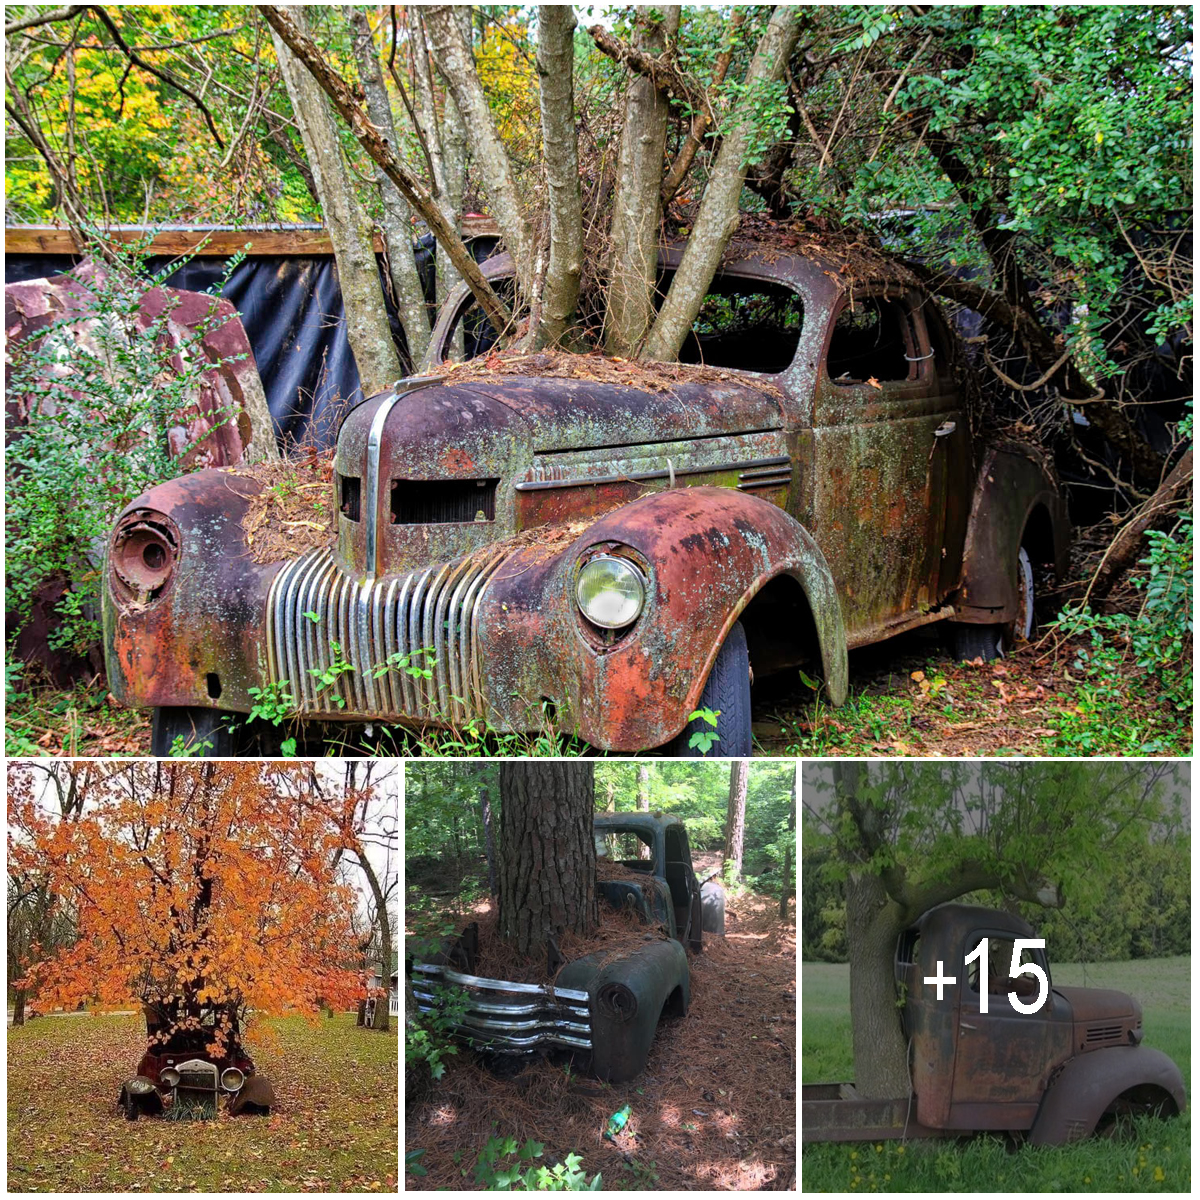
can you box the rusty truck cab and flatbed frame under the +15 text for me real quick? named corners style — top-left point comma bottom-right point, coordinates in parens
top-left (800, 904), bottom-right (1187, 1146)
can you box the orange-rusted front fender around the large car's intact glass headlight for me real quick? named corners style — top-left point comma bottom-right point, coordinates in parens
top-left (478, 487), bottom-right (847, 751)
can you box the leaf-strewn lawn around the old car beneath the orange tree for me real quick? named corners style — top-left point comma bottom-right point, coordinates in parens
top-left (8, 1014), bottom-right (398, 1192)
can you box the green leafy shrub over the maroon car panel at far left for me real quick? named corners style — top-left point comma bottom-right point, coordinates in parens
top-left (5, 238), bottom-right (248, 654)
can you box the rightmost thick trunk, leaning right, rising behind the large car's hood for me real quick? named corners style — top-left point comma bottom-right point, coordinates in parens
top-left (640, 5), bottom-right (800, 362)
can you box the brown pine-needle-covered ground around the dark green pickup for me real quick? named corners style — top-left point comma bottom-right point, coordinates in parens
top-left (404, 894), bottom-right (796, 1190)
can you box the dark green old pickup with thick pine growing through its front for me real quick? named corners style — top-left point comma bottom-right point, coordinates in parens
top-left (406, 812), bottom-right (725, 1082)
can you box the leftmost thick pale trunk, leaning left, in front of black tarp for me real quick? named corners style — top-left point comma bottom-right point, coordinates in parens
top-left (271, 7), bottom-right (403, 396)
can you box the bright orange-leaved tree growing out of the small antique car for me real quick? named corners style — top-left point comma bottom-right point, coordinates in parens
top-left (8, 762), bottom-right (364, 1054)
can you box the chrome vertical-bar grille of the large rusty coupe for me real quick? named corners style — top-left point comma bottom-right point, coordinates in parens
top-left (266, 548), bottom-right (505, 724)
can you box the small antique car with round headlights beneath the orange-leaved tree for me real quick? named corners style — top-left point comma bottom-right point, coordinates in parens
top-left (116, 1006), bottom-right (275, 1121)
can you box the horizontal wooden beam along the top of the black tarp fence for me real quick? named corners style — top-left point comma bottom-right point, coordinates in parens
top-left (4, 216), bottom-right (498, 258)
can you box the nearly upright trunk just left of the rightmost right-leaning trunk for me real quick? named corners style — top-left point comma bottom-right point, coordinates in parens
top-left (604, 5), bottom-right (683, 358)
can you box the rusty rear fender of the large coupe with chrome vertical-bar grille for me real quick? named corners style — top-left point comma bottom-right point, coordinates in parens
top-left (954, 442), bottom-right (1070, 624)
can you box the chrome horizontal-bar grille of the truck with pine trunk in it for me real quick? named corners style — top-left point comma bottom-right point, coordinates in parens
top-left (412, 962), bottom-right (592, 1054)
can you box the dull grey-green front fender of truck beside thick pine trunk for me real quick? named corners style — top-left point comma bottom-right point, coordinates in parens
top-left (554, 935), bottom-right (691, 1084)
